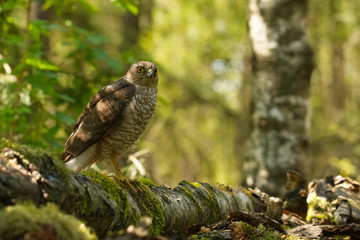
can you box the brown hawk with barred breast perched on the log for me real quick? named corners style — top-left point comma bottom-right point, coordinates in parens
top-left (60, 61), bottom-right (158, 176)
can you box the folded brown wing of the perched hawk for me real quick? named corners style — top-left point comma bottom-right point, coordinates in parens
top-left (60, 78), bottom-right (135, 162)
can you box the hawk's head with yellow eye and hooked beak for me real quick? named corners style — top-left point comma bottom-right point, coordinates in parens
top-left (126, 61), bottom-right (158, 87)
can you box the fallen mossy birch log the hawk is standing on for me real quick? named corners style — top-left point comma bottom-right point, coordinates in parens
top-left (0, 142), bottom-right (259, 235)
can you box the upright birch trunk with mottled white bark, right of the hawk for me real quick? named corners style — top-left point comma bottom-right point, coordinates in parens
top-left (243, 0), bottom-right (313, 195)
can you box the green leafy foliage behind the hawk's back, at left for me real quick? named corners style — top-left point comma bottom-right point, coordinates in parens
top-left (0, 0), bottom-right (135, 149)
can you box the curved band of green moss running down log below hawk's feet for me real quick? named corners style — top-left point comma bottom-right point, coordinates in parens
top-left (121, 179), bottom-right (165, 236)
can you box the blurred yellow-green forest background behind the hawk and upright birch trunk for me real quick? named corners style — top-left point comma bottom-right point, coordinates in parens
top-left (0, 0), bottom-right (360, 186)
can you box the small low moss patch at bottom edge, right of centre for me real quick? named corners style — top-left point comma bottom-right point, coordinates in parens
top-left (232, 222), bottom-right (282, 240)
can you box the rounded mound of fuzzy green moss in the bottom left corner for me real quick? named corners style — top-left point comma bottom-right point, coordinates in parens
top-left (0, 203), bottom-right (97, 240)
